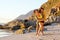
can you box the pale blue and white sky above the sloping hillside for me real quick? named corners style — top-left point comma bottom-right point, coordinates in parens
top-left (0, 0), bottom-right (47, 23)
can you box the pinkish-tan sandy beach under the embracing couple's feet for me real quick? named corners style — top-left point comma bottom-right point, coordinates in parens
top-left (0, 23), bottom-right (60, 40)
